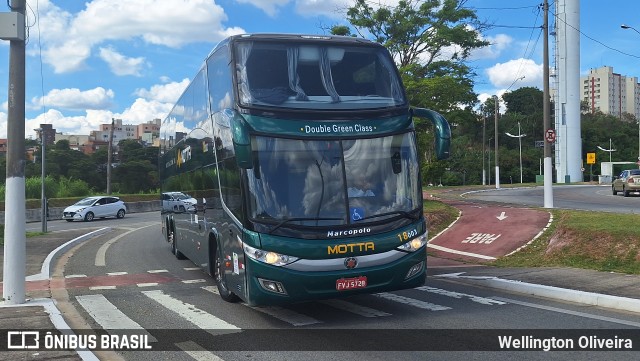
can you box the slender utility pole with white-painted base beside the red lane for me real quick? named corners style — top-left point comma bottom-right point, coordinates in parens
top-left (542, 0), bottom-right (553, 208)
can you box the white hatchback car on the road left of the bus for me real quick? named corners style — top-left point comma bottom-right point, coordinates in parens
top-left (62, 196), bottom-right (127, 222)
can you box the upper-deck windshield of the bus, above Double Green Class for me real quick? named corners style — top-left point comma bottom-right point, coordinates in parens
top-left (235, 41), bottom-right (406, 110)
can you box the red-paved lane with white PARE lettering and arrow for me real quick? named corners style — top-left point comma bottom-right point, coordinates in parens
top-left (428, 200), bottom-right (551, 262)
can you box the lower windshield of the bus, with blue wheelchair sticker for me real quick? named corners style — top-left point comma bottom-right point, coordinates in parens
top-left (247, 133), bottom-right (421, 227)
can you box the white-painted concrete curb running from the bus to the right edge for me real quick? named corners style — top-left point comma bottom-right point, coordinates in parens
top-left (434, 273), bottom-right (640, 313)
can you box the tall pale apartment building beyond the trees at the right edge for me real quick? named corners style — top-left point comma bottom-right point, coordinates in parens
top-left (580, 66), bottom-right (640, 119)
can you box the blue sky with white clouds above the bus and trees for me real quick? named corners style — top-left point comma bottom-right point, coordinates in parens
top-left (0, 0), bottom-right (640, 138)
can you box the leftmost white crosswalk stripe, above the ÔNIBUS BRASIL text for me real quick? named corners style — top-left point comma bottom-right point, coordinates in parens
top-left (76, 295), bottom-right (157, 342)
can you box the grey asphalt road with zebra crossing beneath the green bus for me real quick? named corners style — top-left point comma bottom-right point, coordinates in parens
top-left (48, 215), bottom-right (640, 361)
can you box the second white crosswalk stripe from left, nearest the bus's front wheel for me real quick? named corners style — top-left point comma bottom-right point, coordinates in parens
top-left (142, 290), bottom-right (240, 330)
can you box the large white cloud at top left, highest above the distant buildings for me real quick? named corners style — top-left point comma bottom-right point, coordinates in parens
top-left (39, 0), bottom-right (244, 73)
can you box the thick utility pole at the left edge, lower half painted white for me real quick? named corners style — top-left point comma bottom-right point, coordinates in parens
top-left (2, 0), bottom-right (27, 305)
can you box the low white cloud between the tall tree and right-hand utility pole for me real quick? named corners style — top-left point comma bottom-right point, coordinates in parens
top-left (486, 58), bottom-right (542, 88)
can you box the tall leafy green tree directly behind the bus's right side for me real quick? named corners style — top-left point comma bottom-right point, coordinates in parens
top-left (331, 0), bottom-right (489, 184)
